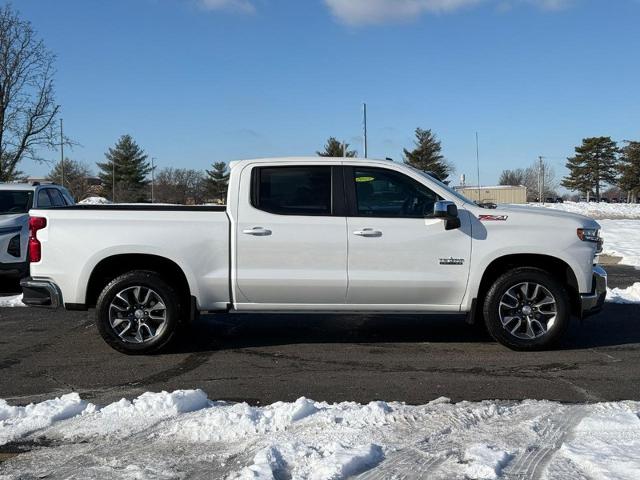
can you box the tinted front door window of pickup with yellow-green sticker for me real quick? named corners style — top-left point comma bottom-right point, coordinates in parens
top-left (353, 167), bottom-right (439, 218)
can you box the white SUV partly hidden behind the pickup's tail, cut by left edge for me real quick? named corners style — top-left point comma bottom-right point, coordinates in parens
top-left (0, 182), bottom-right (74, 279)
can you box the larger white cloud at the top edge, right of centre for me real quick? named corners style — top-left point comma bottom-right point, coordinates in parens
top-left (324, 0), bottom-right (574, 25)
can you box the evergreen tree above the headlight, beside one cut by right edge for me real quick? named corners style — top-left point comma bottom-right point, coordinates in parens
top-left (562, 137), bottom-right (619, 201)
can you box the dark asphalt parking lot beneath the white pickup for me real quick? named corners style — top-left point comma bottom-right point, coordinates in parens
top-left (0, 266), bottom-right (640, 404)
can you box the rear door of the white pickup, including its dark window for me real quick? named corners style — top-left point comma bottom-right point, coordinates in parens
top-left (235, 164), bottom-right (347, 310)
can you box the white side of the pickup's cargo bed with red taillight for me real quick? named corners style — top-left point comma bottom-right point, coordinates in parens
top-left (30, 204), bottom-right (230, 310)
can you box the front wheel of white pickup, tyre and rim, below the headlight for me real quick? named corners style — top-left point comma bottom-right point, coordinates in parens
top-left (483, 268), bottom-right (570, 350)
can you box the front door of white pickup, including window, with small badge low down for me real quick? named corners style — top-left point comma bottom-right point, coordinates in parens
top-left (345, 166), bottom-right (471, 310)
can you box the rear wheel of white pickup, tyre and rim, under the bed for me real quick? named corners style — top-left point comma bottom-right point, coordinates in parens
top-left (96, 270), bottom-right (180, 355)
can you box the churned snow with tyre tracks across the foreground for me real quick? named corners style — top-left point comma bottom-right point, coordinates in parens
top-left (0, 390), bottom-right (640, 480)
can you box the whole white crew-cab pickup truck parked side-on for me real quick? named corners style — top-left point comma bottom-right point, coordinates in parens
top-left (22, 158), bottom-right (607, 354)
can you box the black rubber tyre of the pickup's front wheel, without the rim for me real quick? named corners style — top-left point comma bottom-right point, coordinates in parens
top-left (482, 267), bottom-right (571, 351)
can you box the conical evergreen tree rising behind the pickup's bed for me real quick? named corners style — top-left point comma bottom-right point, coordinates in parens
top-left (98, 135), bottom-right (151, 202)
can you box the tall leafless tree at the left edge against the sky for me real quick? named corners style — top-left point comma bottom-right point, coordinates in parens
top-left (0, 4), bottom-right (60, 181)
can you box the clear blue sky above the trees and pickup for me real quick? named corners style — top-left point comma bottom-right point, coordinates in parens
top-left (13, 0), bottom-right (640, 184)
